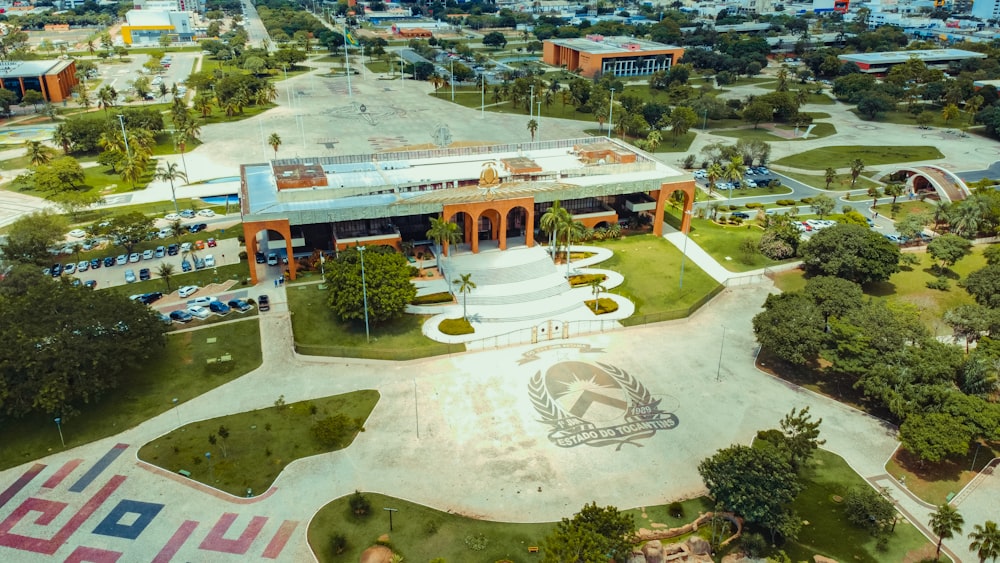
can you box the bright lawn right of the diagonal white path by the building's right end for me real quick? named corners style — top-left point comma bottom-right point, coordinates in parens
top-left (666, 207), bottom-right (796, 276)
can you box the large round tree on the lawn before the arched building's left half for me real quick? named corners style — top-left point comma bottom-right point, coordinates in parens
top-left (326, 246), bottom-right (417, 324)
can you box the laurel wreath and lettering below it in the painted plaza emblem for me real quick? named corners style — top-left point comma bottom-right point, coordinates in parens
top-left (528, 362), bottom-right (677, 450)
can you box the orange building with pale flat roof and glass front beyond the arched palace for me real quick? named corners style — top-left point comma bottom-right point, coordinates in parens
top-left (542, 35), bottom-right (684, 78)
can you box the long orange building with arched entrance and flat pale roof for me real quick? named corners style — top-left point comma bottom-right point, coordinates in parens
top-left (240, 137), bottom-right (695, 283)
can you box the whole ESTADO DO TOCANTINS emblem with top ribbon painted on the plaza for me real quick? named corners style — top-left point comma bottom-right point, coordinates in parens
top-left (521, 345), bottom-right (679, 450)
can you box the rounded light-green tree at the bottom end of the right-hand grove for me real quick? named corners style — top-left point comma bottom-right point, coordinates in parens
top-left (899, 412), bottom-right (972, 468)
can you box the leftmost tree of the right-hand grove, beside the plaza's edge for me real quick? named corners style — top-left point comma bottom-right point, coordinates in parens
top-left (753, 293), bottom-right (826, 365)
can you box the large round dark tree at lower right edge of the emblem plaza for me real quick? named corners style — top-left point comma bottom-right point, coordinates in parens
top-left (698, 445), bottom-right (802, 539)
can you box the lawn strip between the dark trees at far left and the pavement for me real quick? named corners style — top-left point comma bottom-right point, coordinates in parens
top-left (0, 321), bottom-right (261, 469)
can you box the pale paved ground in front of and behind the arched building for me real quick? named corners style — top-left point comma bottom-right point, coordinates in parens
top-left (0, 55), bottom-right (1000, 562)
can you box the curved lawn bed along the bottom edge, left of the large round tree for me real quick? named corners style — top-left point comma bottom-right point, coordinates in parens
top-left (308, 490), bottom-right (712, 563)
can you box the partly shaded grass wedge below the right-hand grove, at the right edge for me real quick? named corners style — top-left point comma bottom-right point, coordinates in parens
top-left (885, 442), bottom-right (1000, 505)
